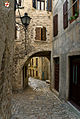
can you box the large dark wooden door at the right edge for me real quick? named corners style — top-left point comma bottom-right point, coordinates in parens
top-left (70, 56), bottom-right (80, 106)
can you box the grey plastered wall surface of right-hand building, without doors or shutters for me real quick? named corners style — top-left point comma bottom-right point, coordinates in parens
top-left (52, 0), bottom-right (80, 99)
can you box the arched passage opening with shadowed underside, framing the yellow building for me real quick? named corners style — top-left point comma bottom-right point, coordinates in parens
top-left (22, 51), bottom-right (51, 89)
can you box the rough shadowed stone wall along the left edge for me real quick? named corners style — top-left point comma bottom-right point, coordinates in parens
top-left (0, 0), bottom-right (14, 119)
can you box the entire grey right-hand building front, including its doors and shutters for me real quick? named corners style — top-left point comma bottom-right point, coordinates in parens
top-left (52, 0), bottom-right (80, 109)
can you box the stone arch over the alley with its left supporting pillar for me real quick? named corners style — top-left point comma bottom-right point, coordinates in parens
top-left (12, 49), bottom-right (51, 90)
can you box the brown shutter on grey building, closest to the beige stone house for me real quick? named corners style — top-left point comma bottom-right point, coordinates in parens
top-left (53, 14), bottom-right (58, 37)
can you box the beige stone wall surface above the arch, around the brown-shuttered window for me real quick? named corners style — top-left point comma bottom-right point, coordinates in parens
top-left (13, 0), bottom-right (52, 89)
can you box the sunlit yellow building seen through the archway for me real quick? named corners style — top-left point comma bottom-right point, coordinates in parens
top-left (28, 57), bottom-right (50, 81)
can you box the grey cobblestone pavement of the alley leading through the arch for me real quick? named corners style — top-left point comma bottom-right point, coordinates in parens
top-left (11, 78), bottom-right (80, 119)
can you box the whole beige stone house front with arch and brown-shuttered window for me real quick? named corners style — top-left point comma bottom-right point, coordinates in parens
top-left (13, 0), bottom-right (52, 90)
